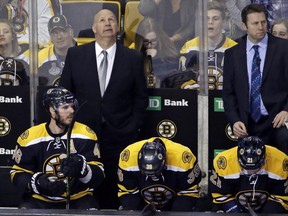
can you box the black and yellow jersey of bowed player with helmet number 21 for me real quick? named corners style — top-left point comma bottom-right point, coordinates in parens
top-left (210, 145), bottom-right (288, 212)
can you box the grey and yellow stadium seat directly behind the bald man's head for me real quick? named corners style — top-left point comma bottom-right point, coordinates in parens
top-left (61, 0), bottom-right (121, 45)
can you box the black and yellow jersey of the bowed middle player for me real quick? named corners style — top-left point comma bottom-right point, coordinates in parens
top-left (118, 137), bottom-right (201, 210)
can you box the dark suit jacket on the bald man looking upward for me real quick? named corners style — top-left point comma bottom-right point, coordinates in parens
top-left (60, 42), bottom-right (148, 148)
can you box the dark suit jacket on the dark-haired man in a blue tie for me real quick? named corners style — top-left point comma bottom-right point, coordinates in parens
top-left (223, 34), bottom-right (288, 127)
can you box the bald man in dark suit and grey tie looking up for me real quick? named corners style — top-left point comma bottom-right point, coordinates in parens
top-left (59, 9), bottom-right (148, 209)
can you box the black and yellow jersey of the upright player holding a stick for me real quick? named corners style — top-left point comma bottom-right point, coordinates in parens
top-left (10, 122), bottom-right (104, 202)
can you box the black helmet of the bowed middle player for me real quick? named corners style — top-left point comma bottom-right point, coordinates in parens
top-left (138, 139), bottom-right (166, 176)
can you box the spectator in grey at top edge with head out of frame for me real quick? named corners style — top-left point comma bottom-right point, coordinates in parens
top-left (138, 0), bottom-right (197, 50)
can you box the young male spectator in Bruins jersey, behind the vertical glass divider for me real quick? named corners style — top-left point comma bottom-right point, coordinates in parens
top-left (180, 1), bottom-right (236, 90)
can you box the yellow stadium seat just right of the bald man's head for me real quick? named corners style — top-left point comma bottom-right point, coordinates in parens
top-left (124, 1), bottom-right (143, 47)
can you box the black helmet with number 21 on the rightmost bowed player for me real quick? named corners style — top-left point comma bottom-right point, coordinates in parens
top-left (237, 136), bottom-right (266, 170)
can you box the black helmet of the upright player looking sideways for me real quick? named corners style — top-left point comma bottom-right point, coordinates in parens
top-left (43, 87), bottom-right (78, 112)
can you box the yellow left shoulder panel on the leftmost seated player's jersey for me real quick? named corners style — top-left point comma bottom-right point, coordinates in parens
top-left (17, 123), bottom-right (49, 147)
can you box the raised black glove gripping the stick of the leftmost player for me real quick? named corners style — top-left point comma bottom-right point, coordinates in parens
top-left (60, 154), bottom-right (88, 178)
